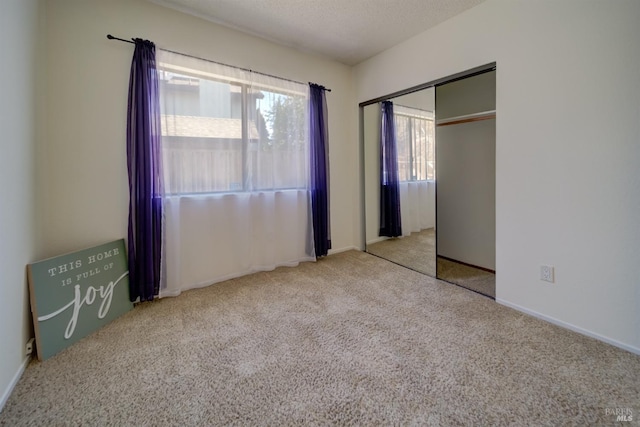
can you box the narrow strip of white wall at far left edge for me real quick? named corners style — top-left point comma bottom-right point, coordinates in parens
top-left (0, 0), bottom-right (39, 409)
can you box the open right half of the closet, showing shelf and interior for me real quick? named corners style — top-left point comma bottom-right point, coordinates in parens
top-left (436, 71), bottom-right (496, 298)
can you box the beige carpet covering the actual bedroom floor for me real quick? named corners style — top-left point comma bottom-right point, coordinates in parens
top-left (0, 251), bottom-right (640, 426)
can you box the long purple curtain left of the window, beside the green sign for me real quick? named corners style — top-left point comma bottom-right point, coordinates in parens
top-left (127, 39), bottom-right (162, 301)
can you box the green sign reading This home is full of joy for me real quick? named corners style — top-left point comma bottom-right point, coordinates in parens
top-left (27, 239), bottom-right (133, 360)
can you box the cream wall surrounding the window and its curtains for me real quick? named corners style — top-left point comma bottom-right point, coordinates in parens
top-left (40, 0), bottom-right (359, 255)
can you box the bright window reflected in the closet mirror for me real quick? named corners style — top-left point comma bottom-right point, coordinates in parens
top-left (394, 105), bottom-right (435, 181)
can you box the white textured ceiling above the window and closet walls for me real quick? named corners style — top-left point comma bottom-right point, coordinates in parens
top-left (150, 0), bottom-right (485, 65)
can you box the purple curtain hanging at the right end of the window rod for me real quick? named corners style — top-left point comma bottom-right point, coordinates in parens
top-left (309, 83), bottom-right (331, 257)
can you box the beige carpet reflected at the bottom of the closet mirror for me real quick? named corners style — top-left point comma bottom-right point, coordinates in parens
top-left (367, 228), bottom-right (436, 277)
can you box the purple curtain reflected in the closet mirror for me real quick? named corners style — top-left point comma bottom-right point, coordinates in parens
top-left (379, 101), bottom-right (402, 237)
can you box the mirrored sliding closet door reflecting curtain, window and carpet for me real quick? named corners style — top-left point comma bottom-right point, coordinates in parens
top-left (363, 87), bottom-right (436, 277)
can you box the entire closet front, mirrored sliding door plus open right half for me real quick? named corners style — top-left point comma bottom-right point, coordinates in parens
top-left (360, 64), bottom-right (495, 298)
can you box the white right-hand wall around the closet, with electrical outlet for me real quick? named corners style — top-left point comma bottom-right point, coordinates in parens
top-left (354, 0), bottom-right (640, 353)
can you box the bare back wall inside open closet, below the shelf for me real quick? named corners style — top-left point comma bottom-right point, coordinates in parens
top-left (436, 119), bottom-right (496, 270)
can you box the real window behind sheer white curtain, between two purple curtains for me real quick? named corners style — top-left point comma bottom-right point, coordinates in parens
top-left (158, 51), bottom-right (308, 194)
